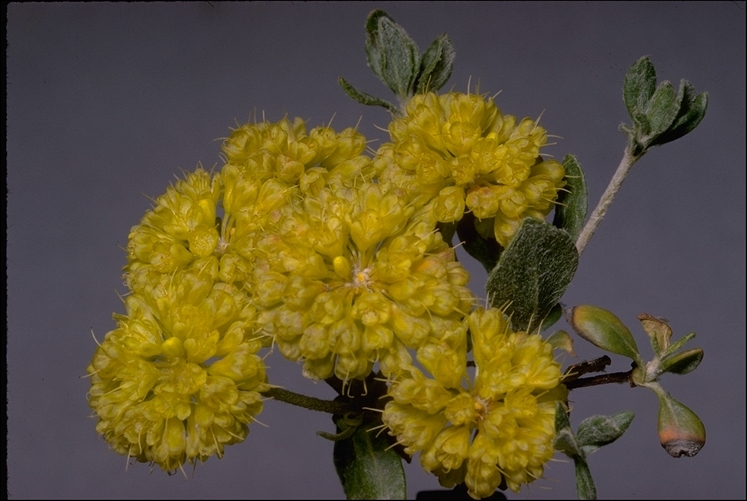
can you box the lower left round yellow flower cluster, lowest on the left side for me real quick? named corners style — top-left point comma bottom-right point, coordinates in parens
top-left (87, 270), bottom-right (269, 471)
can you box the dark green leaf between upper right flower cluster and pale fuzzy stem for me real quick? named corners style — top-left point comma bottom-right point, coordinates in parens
top-left (552, 154), bottom-right (589, 242)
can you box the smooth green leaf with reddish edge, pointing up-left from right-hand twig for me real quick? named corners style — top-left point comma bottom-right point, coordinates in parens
top-left (568, 305), bottom-right (644, 367)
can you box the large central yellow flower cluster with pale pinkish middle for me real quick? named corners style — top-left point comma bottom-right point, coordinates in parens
top-left (254, 180), bottom-right (472, 380)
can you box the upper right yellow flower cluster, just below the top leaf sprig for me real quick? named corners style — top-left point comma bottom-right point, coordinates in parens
top-left (378, 92), bottom-right (565, 247)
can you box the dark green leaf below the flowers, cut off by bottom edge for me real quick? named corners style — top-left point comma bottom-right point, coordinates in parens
top-left (333, 416), bottom-right (407, 499)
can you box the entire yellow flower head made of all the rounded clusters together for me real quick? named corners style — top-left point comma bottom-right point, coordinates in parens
top-left (88, 93), bottom-right (564, 484)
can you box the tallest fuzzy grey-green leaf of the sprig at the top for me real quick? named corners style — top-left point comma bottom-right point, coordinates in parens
top-left (366, 10), bottom-right (420, 101)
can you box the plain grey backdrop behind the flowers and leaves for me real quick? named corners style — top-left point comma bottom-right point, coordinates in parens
top-left (7, 2), bottom-right (745, 499)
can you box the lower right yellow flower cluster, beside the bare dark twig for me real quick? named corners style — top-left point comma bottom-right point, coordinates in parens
top-left (382, 309), bottom-right (567, 499)
